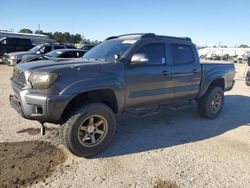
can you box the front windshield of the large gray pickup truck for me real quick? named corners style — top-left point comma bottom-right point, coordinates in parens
top-left (83, 39), bottom-right (136, 62)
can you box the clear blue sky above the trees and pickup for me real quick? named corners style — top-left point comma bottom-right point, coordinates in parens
top-left (0, 0), bottom-right (250, 46)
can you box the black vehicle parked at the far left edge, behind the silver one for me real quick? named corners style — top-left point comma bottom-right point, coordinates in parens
top-left (0, 37), bottom-right (34, 62)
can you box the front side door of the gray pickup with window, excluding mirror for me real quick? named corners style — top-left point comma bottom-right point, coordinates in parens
top-left (126, 42), bottom-right (171, 108)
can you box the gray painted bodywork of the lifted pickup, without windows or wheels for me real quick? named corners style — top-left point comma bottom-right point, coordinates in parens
top-left (9, 34), bottom-right (235, 123)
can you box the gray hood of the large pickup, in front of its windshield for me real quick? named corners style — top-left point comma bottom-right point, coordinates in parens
top-left (16, 58), bottom-right (109, 72)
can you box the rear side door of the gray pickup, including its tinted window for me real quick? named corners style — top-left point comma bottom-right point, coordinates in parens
top-left (169, 43), bottom-right (201, 101)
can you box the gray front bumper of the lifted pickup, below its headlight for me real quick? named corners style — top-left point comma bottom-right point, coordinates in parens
top-left (9, 83), bottom-right (70, 124)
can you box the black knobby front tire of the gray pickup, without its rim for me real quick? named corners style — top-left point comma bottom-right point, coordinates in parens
top-left (60, 103), bottom-right (116, 157)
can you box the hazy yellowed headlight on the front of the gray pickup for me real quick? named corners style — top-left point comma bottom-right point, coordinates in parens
top-left (28, 72), bottom-right (58, 90)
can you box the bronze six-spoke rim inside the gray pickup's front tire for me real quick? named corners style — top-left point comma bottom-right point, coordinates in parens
top-left (78, 115), bottom-right (108, 147)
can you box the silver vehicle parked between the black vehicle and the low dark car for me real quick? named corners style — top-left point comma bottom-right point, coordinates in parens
top-left (3, 43), bottom-right (75, 66)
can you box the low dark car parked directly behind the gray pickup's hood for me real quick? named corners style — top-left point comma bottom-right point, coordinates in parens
top-left (20, 49), bottom-right (85, 63)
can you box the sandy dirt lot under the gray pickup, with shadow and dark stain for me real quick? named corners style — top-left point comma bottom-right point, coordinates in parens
top-left (0, 65), bottom-right (250, 187)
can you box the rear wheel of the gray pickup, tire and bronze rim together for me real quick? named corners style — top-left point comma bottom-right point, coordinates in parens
top-left (197, 87), bottom-right (224, 119)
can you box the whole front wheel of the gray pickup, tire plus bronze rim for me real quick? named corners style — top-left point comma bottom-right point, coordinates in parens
top-left (61, 103), bottom-right (116, 157)
